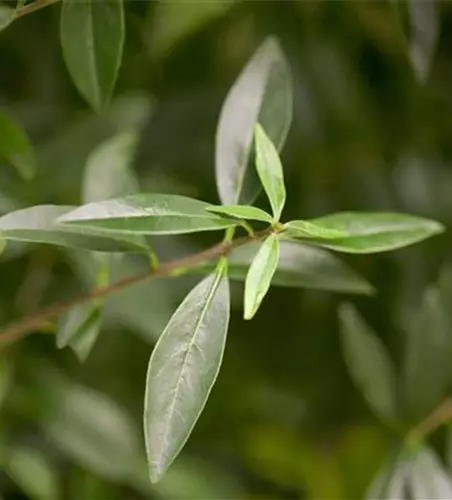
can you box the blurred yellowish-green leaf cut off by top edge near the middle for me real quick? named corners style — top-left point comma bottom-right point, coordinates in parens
top-left (147, 0), bottom-right (235, 56)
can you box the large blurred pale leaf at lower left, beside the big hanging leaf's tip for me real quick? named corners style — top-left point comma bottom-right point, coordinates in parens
top-left (39, 372), bottom-right (142, 482)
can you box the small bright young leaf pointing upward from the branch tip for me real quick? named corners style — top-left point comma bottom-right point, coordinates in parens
top-left (255, 124), bottom-right (286, 220)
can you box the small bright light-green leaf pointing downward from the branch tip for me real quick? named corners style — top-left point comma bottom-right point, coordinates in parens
top-left (244, 234), bottom-right (279, 319)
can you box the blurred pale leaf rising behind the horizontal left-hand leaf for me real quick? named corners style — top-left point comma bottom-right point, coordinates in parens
top-left (82, 132), bottom-right (138, 203)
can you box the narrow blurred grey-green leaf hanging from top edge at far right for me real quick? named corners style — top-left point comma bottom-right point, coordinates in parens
top-left (408, 0), bottom-right (439, 83)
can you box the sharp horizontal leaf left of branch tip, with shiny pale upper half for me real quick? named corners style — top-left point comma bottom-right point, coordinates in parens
top-left (60, 194), bottom-right (237, 234)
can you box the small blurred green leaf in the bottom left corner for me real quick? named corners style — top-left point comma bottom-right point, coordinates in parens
top-left (6, 446), bottom-right (59, 500)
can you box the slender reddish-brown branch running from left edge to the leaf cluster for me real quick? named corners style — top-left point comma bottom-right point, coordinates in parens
top-left (0, 229), bottom-right (271, 350)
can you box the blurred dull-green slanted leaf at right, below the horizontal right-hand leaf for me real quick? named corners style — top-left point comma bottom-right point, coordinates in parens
top-left (339, 304), bottom-right (397, 422)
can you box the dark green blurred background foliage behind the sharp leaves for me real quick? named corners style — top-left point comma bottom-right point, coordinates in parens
top-left (0, 0), bottom-right (452, 500)
